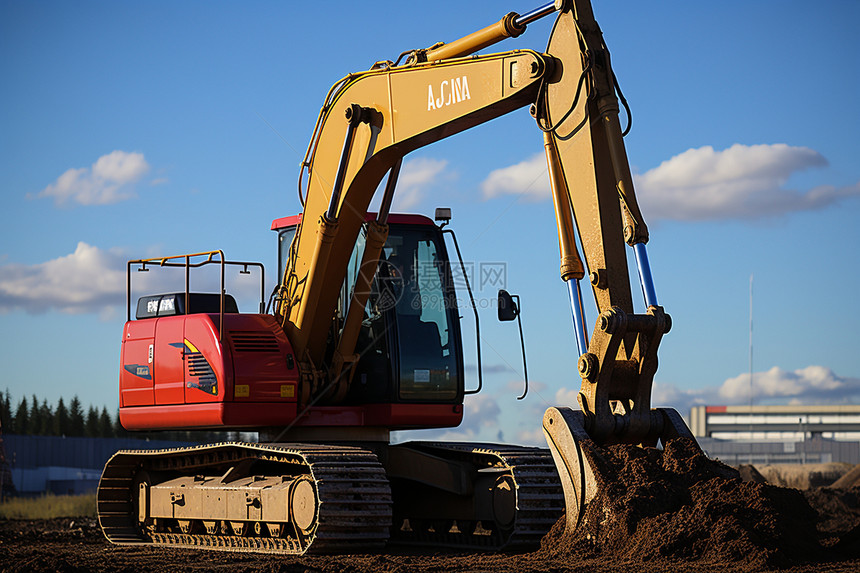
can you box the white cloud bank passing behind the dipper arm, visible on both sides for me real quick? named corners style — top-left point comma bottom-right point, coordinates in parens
top-left (481, 143), bottom-right (860, 220)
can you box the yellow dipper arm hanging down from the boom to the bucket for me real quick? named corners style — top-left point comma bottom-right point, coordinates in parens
top-left (537, 0), bottom-right (671, 443)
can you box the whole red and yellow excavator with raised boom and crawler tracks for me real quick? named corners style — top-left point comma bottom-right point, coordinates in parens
top-left (97, 0), bottom-right (692, 554)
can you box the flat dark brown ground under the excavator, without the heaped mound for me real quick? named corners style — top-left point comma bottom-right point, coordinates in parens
top-left (0, 519), bottom-right (860, 573)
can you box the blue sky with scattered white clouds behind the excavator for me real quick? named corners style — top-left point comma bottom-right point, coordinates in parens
top-left (0, 0), bottom-right (860, 443)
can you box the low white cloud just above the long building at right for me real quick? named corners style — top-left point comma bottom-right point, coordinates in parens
top-left (651, 365), bottom-right (860, 416)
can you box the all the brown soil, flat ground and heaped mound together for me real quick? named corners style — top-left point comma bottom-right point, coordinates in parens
top-left (0, 440), bottom-right (860, 573)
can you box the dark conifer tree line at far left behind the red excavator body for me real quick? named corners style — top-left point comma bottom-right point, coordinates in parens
top-left (0, 390), bottom-right (231, 442)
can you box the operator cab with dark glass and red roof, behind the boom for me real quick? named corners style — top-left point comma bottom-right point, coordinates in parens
top-left (272, 213), bottom-right (464, 404)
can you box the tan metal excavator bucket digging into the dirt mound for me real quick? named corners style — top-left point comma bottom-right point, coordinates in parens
top-left (543, 407), bottom-right (697, 533)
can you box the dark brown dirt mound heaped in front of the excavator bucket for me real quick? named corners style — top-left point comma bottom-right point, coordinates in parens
top-left (542, 439), bottom-right (823, 569)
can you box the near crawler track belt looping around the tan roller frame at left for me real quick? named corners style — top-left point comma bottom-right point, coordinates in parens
top-left (97, 444), bottom-right (392, 554)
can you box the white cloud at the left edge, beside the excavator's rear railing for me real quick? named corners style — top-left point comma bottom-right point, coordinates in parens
top-left (0, 242), bottom-right (125, 314)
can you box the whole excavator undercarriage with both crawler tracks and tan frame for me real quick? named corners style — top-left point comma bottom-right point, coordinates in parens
top-left (98, 442), bottom-right (564, 555)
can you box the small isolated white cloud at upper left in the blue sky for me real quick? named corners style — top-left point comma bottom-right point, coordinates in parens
top-left (31, 150), bottom-right (149, 205)
